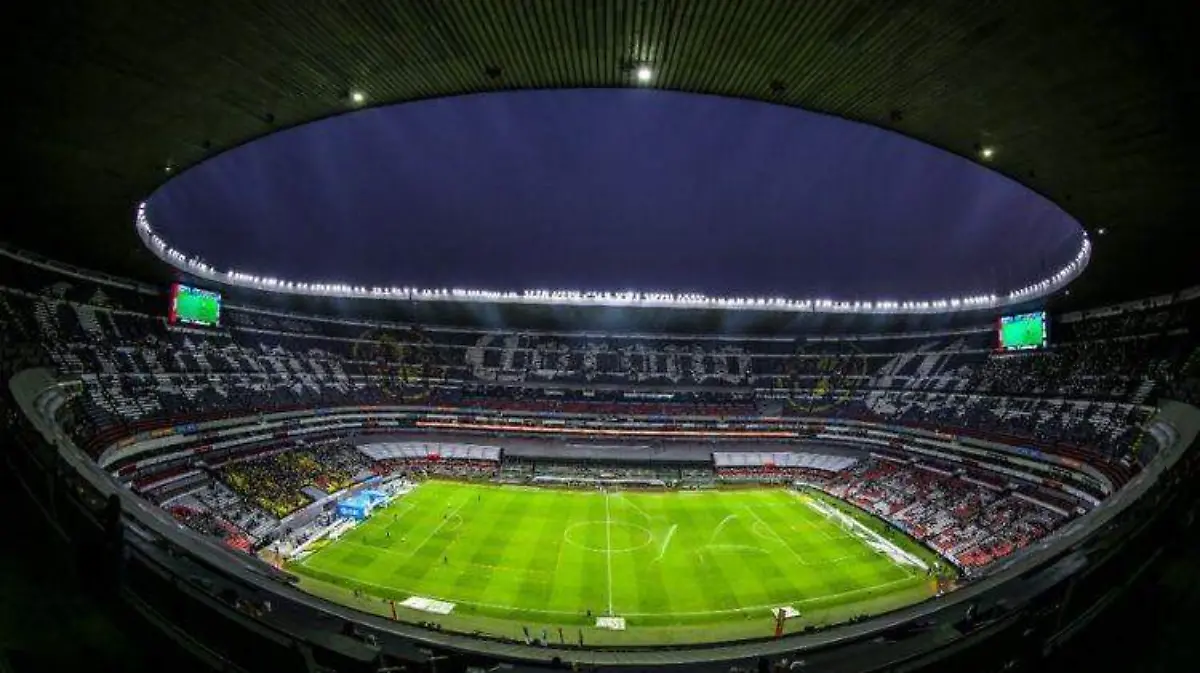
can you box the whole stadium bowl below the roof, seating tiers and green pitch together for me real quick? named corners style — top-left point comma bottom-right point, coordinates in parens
top-left (0, 239), bottom-right (1200, 662)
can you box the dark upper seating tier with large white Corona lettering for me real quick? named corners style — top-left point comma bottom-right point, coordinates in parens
top-left (0, 248), bottom-right (1200, 477)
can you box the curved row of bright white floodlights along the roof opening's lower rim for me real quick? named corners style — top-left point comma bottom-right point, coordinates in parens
top-left (136, 203), bottom-right (1092, 314)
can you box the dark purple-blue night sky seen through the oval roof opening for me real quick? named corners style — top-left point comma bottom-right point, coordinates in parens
top-left (149, 89), bottom-right (1082, 300)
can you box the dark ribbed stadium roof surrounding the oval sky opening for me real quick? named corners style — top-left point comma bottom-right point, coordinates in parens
top-left (4, 0), bottom-right (1200, 314)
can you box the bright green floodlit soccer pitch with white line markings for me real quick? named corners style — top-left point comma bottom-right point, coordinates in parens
top-left (289, 481), bottom-right (936, 643)
